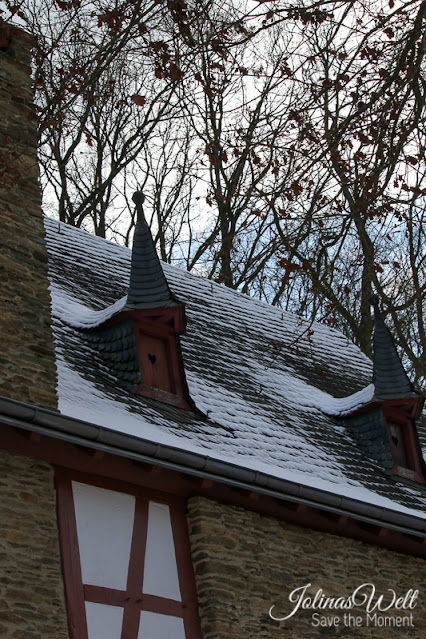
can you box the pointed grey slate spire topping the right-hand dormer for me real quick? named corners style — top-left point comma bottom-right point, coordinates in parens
top-left (370, 295), bottom-right (420, 400)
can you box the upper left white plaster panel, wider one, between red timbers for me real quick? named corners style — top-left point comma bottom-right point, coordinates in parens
top-left (72, 482), bottom-right (135, 590)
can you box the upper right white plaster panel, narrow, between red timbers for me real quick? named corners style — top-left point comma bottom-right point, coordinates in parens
top-left (143, 502), bottom-right (181, 601)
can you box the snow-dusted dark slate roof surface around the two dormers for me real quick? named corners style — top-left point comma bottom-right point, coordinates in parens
top-left (45, 219), bottom-right (426, 517)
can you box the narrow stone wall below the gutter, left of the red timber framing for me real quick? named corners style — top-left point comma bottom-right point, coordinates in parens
top-left (0, 451), bottom-right (68, 639)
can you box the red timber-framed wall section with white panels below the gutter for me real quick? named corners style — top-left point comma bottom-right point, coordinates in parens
top-left (57, 476), bottom-right (201, 639)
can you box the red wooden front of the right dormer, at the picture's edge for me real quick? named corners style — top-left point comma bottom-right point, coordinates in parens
top-left (382, 397), bottom-right (426, 484)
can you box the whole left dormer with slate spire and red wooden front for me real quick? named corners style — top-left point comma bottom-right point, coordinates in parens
top-left (91, 193), bottom-right (193, 409)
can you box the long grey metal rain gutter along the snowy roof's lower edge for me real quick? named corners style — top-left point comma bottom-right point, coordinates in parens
top-left (0, 397), bottom-right (426, 538)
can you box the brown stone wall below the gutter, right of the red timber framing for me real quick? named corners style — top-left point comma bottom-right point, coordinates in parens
top-left (188, 497), bottom-right (426, 639)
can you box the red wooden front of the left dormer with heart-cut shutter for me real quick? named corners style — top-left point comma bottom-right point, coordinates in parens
top-left (104, 306), bottom-right (191, 410)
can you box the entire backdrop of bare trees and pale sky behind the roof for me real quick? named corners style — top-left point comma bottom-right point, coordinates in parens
top-left (5, 0), bottom-right (426, 383)
